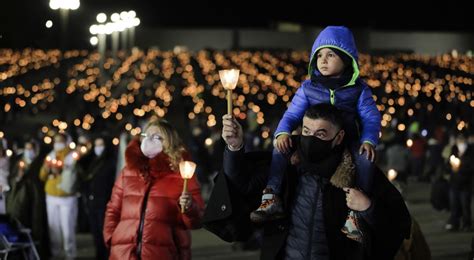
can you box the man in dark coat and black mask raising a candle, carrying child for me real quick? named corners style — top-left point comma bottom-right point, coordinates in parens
top-left (203, 105), bottom-right (411, 259)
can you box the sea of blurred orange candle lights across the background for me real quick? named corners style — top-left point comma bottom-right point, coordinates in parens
top-left (0, 49), bottom-right (474, 146)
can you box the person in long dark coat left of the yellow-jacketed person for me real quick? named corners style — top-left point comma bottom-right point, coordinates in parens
top-left (6, 142), bottom-right (50, 259)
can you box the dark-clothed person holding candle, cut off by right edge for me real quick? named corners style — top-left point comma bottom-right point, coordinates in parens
top-left (445, 134), bottom-right (474, 231)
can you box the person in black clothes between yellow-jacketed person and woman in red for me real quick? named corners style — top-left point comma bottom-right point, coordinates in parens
top-left (80, 137), bottom-right (116, 259)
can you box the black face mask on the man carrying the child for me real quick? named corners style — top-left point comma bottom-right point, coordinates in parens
top-left (299, 132), bottom-right (339, 163)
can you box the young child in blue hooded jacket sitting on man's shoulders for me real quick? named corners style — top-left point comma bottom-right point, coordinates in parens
top-left (250, 26), bottom-right (381, 240)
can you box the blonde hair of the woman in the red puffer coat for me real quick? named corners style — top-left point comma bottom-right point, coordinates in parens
top-left (145, 119), bottom-right (186, 171)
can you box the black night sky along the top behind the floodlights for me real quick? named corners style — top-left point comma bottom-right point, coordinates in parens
top-left (0, 0), bottom-right (474, 48)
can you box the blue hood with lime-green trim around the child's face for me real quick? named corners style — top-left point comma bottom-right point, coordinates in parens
top-left (308, 26), bottom-right (359, 86)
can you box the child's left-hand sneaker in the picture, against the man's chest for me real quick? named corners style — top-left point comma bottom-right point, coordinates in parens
top-left (250, 188), bottom-right (283, 223)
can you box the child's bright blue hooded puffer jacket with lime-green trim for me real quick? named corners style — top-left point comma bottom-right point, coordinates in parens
top-left (275, 26), bottom-right (381, 146)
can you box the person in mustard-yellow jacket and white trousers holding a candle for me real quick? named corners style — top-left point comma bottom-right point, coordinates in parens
top-left (39, 134), bottom-right (78, 259)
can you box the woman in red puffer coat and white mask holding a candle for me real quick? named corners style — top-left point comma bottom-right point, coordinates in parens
top-left (104, 120), bottom-right (204, 260)
